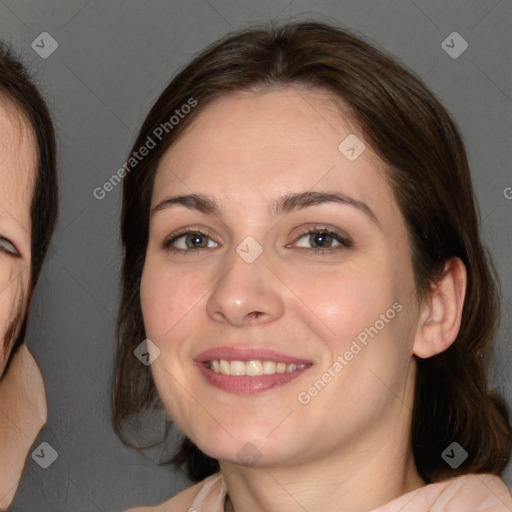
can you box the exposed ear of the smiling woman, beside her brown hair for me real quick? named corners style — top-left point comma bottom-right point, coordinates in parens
top-left (413, 257), bottom-right (467, 358)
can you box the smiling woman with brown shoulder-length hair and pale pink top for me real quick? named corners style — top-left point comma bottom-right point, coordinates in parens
top-left (113, 23), bottom-right (512, 512)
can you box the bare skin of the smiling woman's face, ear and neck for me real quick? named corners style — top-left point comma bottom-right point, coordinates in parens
top-left (140, 88), bottom-right (466, 512)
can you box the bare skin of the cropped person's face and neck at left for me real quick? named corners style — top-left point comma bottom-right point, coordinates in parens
top-left (0, 101), bottom-right (47, 510)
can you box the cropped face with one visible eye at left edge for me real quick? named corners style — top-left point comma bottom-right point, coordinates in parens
top-left (0, 100), bottom-right (36, 376)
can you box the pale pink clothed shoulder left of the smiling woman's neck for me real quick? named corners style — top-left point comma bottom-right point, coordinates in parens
top-left (126, 473), bottom-right (226, 512)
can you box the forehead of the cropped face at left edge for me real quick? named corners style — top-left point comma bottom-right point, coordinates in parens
top-left (0, 97), bottom-right (37, 227)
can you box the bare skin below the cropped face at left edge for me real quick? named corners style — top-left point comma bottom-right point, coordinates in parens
top-left (0, 344), bottom-right (47, 510)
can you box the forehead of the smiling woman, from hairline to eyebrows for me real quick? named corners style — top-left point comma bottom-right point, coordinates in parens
top-left (152, 87), bottom-right (396, 222)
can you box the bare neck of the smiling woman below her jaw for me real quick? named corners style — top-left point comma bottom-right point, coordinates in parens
top-left (220, 362), bottom-right (425, 512)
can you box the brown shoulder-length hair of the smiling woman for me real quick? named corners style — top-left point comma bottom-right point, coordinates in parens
top-left (112, 22), bottom-right (511, 482)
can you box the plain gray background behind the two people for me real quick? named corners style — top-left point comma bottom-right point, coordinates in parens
top-left (0, 0), bottom-right (512, 512)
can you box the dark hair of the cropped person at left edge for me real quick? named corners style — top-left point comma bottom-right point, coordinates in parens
top-left (0, 41), bottom-right (58, 364)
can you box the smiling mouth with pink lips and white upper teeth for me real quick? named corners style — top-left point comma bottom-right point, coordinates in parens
top-left (195, 349), bottom-right (312, 395)
